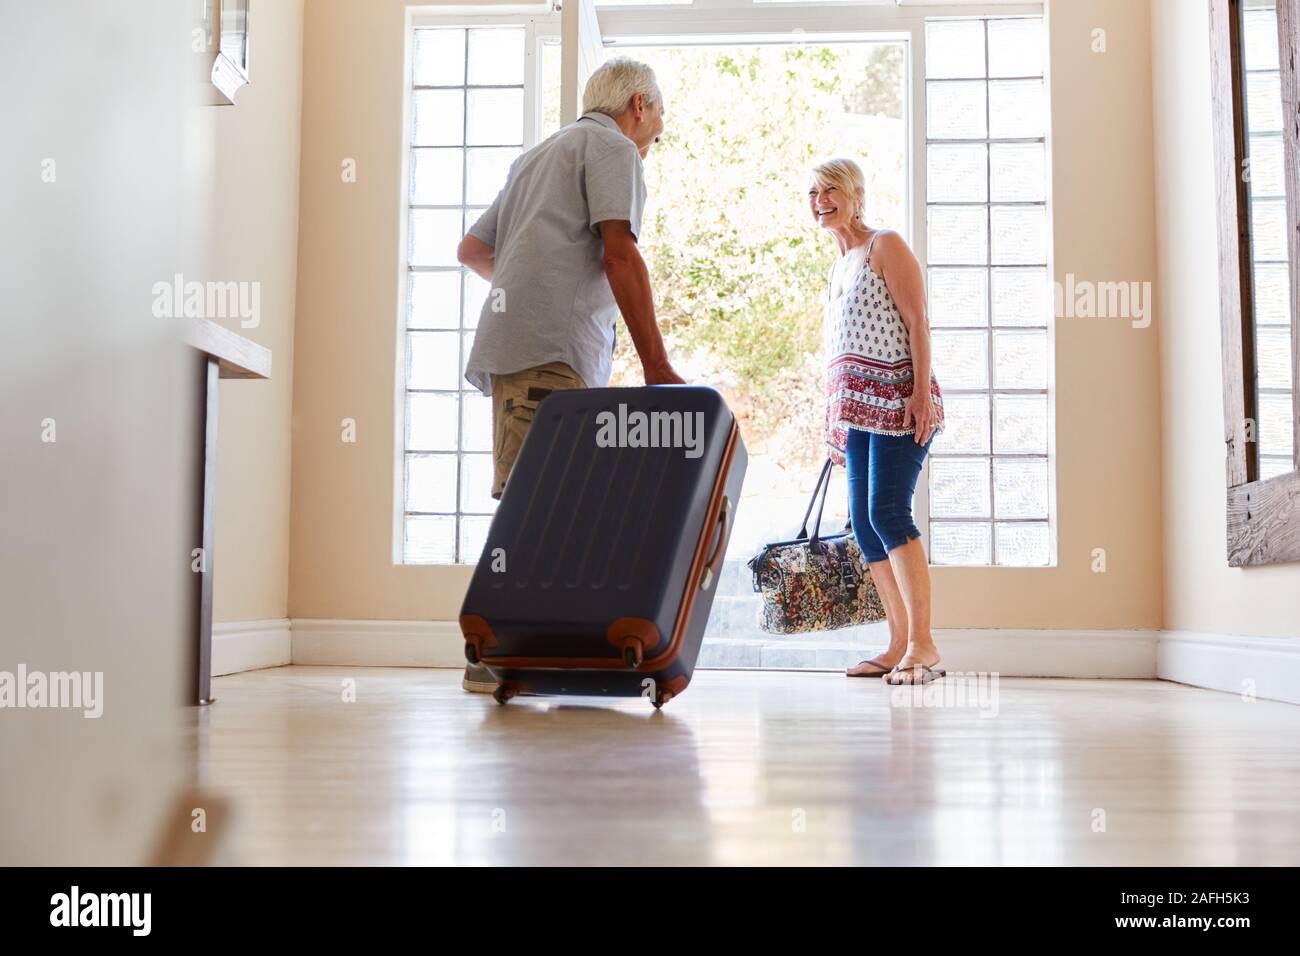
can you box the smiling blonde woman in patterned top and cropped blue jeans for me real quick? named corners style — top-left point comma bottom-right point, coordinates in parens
top-left (809, 159), bottom-right (944, 684)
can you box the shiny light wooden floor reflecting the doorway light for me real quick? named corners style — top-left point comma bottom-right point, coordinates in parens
top-left (191, 667), bottom-right (1300, 865)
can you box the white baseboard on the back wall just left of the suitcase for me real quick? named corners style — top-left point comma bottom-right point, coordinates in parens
top-left (291, 618), bottom-right (465, 667)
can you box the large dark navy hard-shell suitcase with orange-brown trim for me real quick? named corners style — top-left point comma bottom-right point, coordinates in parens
top-left (460, 385), bottom-right (746, 708)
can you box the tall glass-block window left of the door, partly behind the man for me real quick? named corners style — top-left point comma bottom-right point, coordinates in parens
top-left (400, 25), bottom-right (533, 564)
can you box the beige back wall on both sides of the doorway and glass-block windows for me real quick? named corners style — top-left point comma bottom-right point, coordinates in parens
top-left (289, 0), bottom-right (1161, 627)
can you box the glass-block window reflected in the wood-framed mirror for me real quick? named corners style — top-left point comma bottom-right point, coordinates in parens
top-left (1242, 3), bottom-right (1295, 479)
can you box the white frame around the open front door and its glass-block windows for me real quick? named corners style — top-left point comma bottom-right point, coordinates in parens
top-left (393, 0), bottom-right (1057, 567)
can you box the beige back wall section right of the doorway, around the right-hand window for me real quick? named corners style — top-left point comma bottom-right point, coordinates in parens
top-left (935, 0), bottom-right (1162, 628)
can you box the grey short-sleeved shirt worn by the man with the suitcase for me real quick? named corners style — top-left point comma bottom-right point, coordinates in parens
top-left (465, 113), bottom-right (646, 395)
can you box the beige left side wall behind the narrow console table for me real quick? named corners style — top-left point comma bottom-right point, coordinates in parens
top-left (205, 0), bottom-right (303, 622)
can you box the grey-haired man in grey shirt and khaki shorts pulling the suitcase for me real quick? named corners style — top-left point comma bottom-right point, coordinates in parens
top-left (456, 59), bottom-right (681, 692)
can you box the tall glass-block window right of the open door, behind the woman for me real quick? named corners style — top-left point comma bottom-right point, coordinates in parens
top-left (926, 17), bottom-right (1054, 567)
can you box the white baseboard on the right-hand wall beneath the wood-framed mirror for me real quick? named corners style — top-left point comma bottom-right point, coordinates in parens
top-left (1156, 631), bottom-right (1300, 704)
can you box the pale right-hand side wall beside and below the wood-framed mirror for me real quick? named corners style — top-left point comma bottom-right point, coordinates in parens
top-left (1152, 0), bottom-right (1300, 637)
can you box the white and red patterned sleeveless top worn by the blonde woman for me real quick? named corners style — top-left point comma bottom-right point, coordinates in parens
top-left (824, 232), bottom-right (944, 464)
